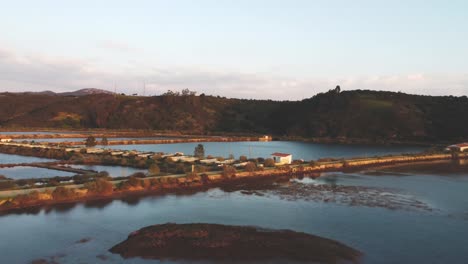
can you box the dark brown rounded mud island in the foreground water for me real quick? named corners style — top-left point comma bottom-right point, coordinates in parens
top-left (109, 223), bottom-right (362, 263)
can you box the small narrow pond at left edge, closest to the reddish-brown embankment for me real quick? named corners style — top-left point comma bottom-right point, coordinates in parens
top-left (0, 166), bottom-right (76, 180)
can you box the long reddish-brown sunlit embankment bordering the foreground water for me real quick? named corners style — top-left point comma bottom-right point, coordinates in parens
top-left (0, 153), bottom-right (468, 212)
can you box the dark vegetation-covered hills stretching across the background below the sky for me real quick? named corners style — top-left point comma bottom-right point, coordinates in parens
top-left (0, 90), bottom-right (468, 141)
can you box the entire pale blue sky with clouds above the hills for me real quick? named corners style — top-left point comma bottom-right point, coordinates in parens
top-left (0, 0), bottom-right (468, 100)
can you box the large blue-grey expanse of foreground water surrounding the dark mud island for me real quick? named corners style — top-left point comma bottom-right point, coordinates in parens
top-left (0, 162), bottom-right (468, 263)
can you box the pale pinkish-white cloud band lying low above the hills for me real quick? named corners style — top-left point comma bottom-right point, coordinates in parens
top-left (0, 49), bottom-right (468, 100)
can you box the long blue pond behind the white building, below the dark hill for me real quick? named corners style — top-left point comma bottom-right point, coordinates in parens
top-left (108, 141), bottom-right (424, 160)
